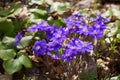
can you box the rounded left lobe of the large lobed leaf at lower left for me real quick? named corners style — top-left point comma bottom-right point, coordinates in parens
top-left (3, 58), bottom-right (22, 74)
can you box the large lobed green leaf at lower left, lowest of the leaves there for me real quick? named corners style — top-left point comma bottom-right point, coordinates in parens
top-left (3, 52), bottom-right (32, 74)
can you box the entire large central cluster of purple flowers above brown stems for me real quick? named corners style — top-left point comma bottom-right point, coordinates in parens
top-left (14, 13), bottom-right (107, 62)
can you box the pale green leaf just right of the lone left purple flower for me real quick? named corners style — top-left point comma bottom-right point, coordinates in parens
top-left (17, 36), bottom-right (32, 49)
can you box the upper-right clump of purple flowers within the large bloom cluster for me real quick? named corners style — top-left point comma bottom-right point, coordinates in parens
top-left (65, 13), bottom-right (108, 39)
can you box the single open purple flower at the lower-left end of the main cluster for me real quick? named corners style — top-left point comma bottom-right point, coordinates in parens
top-left (32, 39), bottom-right (47, 56)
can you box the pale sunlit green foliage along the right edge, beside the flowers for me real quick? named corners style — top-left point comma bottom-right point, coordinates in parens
top-left (103, 8), bottom-right (120, 53)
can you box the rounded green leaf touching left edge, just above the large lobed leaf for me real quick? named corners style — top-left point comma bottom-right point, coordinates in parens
top-left (0, 49), bottom-right (16, 60)
